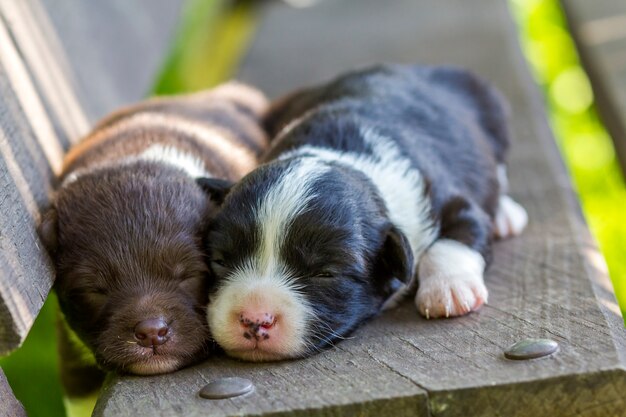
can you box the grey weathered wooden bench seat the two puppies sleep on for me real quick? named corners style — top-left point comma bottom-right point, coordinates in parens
top-left (94, 0), bottom-right (626, 417)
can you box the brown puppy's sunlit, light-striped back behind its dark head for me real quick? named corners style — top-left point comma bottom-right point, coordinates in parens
top-left (61, 82), bottom-right (267, 180)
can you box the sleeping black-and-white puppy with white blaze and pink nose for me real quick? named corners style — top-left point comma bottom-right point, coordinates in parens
top-left (199, 66), bottom-right (527, 361)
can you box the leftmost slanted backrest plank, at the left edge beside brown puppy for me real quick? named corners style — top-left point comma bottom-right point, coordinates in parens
top-left (0, 15), bottom-right (62, 354)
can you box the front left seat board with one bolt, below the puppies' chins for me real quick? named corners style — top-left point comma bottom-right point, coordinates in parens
top-left (94, 346), bottom-right (428, 417)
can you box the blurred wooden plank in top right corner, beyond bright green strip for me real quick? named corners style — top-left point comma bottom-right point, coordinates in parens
top-left (561, 0), bottom-right (626, 175)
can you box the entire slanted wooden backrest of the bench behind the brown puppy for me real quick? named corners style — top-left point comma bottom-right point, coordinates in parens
top-left (0, 0), bottom-right (182, 354)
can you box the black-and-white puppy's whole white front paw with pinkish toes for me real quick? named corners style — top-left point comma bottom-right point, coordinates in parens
top-left (415, 239), bottom-right (488, 318)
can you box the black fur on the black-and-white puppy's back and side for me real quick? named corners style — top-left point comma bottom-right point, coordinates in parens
top-left (264, 65), bottom-right (509, 259)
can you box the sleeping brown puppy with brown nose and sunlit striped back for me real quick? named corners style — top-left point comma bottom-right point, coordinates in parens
top-left (40, 83), bottom-right (267, 374)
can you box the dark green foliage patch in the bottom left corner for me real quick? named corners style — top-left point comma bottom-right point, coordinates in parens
top-left (0, 294), bottom-right (65, 417)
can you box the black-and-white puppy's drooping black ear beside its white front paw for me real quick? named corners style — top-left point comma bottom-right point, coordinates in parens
top-left (378, 226), bottom-right (415, 284)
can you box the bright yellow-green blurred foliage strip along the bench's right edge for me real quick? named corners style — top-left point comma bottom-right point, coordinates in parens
top-left (510, 0), bottom-right (626, 315)
